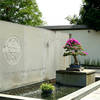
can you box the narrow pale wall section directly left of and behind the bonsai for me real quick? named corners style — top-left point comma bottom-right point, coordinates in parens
top-left (56, 31), bottom-right (71, 70)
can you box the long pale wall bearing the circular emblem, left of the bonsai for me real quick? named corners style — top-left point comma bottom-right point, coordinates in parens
top-left (0, 21), bottom-right (68, 91)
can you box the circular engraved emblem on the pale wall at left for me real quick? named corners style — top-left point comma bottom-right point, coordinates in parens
top-left (3, 36), bottom-right (21, 65)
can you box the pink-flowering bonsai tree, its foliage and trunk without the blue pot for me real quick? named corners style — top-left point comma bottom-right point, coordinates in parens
top-left (63, 38), bottom-right (88, 65)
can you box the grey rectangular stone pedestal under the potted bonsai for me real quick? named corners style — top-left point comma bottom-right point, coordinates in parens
top-left (56, 69), bottom-right (95, 87)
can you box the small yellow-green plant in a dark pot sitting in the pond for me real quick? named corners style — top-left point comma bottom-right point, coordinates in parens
top-left (40, 83), bottom-right (55, 94)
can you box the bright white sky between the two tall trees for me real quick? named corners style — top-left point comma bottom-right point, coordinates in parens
top-left (36, 0), bottom-right (82, 25)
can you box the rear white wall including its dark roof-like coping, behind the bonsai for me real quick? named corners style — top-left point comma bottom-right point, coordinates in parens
top-left (42, 25), bottom-right (100, 66)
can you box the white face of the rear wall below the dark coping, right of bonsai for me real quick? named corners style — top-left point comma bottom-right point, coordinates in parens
top-left (57, 29), bottom-right (100, 63)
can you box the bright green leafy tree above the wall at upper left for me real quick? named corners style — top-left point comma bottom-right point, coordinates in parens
top-left (0, 0), bottom-right (43, 26)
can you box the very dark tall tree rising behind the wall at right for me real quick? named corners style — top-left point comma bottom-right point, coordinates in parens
top-left (67, 0), bottom-right (100, 30)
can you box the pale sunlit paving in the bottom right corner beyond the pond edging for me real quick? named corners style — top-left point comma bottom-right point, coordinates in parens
top-left (81, 88), bottom-right (100, 100)
